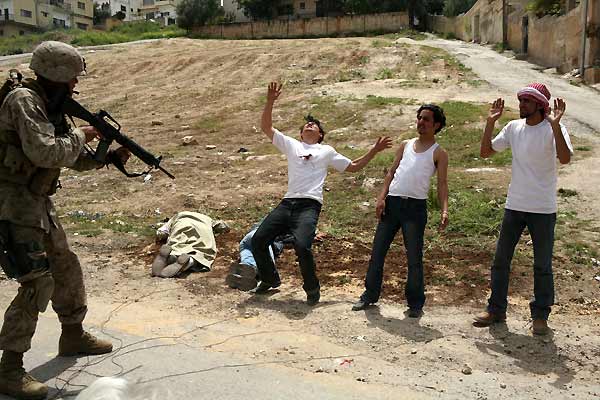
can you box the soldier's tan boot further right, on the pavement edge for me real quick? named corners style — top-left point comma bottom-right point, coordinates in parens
top-left (58, 324), bottom-right (112, 357)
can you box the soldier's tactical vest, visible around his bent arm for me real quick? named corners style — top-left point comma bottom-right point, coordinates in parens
top-left (0, 79), bottom-right (70, 196)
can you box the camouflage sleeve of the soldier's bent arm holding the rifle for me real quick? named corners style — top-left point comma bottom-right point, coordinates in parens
top-left (7, 91), bottom-right (85, 168)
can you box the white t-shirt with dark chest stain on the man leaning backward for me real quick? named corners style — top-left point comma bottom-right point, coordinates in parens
top-left (273, 129), bottom-right (352, 203)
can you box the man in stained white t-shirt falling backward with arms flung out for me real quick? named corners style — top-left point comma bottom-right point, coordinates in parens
top-left (252, 82), bottom-right (392, 305)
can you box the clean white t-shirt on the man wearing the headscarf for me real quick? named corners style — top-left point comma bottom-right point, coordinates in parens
top-left (492, 119), bottom-right (573, 214)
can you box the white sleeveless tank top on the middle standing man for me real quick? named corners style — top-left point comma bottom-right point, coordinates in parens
top-left (388, 138), bottom-right (439, 199)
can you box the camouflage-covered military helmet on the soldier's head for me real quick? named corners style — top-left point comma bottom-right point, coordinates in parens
top-left (29, 40), bottom-right (85, 83)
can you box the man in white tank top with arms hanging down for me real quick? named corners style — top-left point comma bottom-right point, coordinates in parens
top-left (352, 104), bottom-right (448, 318)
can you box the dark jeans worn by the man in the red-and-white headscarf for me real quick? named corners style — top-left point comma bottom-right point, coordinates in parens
top-left (488, 209), bottom-right (556, 320)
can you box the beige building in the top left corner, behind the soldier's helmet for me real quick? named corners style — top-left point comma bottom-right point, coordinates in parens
top-left (0, 0), bottom-right (94, 37)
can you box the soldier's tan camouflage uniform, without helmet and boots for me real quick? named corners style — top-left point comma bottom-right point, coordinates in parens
top-left (0, 81), bottom-right (99, 353)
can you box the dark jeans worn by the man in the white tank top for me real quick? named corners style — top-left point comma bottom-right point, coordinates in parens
top-left (360, 196), bottom-right (427, 310)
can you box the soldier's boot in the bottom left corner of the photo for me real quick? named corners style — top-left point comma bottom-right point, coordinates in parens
top-left (0, 350), bottom-right (48, 400)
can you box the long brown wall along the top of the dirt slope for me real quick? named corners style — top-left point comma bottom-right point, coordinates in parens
top-left (194, 12), bottom-right (408, 39)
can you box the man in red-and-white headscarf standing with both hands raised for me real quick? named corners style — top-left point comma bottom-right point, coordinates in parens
top-left (473, 83), bottom-right (573, 335)
